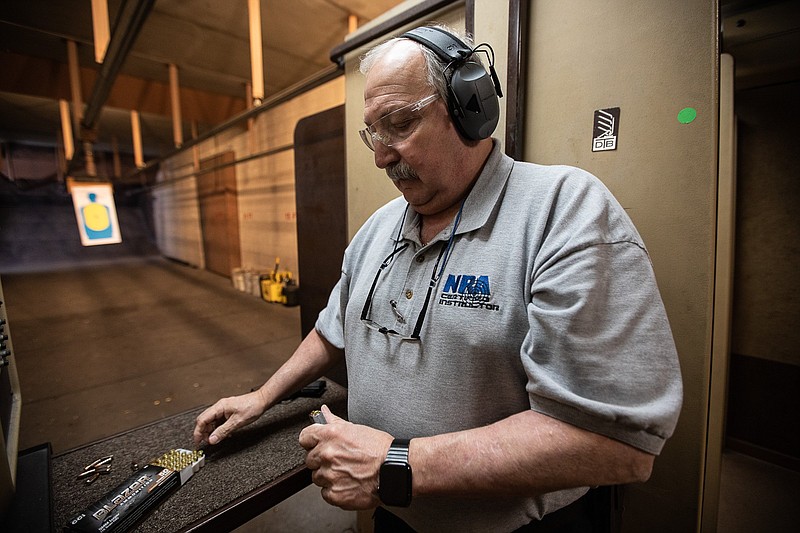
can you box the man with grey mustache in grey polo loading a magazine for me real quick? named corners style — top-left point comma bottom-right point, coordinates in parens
top-left (195, 28), bottom-right (682, 531)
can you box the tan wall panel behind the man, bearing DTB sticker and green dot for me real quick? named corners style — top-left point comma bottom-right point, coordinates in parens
top-left (525, 0), bottom-right (718, 531)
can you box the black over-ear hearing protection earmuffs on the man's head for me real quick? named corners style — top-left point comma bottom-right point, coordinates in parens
top-left (401, 26), bottom-right (503, 141)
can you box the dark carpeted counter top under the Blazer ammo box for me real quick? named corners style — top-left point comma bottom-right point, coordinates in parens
top-left (52, 380), bottom-right (347, 533)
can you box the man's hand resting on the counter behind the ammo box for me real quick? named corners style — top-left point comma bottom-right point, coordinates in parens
top-left (194, 390), bottom-right (267, 444)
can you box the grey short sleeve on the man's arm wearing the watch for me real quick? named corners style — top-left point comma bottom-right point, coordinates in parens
top-left (522, 241), bottom-right (682, 454)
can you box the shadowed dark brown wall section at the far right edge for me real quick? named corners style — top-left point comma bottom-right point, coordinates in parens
top-left (732, 82), bottom-right (800, 365)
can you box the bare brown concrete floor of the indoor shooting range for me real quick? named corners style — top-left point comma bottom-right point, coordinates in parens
top-left (2, 257), bottom-right (800, 533)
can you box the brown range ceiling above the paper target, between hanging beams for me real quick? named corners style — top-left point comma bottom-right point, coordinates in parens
top-left (0, 0), bottom-right (401, 157)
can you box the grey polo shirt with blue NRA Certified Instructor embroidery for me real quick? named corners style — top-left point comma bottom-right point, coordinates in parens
top-left (316, 142), bottom-right (682, 531)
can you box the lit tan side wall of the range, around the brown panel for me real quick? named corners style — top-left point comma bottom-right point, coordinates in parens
top-left (153, 77), bottom-right (345, 276)
